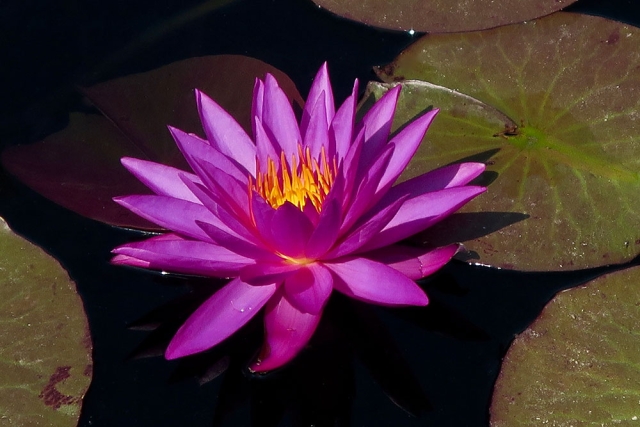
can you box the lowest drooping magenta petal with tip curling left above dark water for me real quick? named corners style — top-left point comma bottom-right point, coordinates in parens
top-left (250, 290), bottom-right (320, 372)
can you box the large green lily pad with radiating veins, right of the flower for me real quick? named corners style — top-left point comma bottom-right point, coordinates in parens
top-left (377, 12), bottom-right (640, 270)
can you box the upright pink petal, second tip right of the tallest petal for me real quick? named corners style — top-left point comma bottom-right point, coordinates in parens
top-left (356, 85), bottom-right (402, 165)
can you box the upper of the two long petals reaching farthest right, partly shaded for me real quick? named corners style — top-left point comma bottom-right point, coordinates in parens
top-left (380, 163), bottom-right (485, 203)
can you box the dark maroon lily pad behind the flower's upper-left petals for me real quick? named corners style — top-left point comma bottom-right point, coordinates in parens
top-left (2, 55), bottom-right (303, 230)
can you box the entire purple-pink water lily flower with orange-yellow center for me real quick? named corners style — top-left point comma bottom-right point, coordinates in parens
top-left (113, 64), bottom-right (485, 372)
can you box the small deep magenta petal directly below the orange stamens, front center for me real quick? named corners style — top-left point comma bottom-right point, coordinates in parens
top-left (271, 202), bottom-right (313, 258)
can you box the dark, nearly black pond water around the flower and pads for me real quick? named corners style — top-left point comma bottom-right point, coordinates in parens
top-left (0, 0), bottom-right (640, 427)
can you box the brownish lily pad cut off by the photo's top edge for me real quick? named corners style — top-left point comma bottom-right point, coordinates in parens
top-left (313, 0), bottom-right (576, 33)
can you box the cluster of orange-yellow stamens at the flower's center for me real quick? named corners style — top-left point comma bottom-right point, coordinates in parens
top-left (249, 145), bottom-right (338, 212)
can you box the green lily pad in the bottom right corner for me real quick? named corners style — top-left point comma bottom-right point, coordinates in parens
top-left (491, 267), bottom-right (640, 427)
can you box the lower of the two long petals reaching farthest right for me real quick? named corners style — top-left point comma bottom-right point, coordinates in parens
top-left (363, 185), bottom-right (487, 250)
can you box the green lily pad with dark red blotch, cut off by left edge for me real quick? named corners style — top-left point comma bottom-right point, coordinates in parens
top-left (0, 219), bottom-right (92, 427)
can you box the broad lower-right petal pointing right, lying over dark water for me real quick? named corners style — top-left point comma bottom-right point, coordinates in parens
top-left (324, 258), bottom-right (429, 306)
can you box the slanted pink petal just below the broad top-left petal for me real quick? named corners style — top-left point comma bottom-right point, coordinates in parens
top-left (169, 126), bottom-right (249, 183)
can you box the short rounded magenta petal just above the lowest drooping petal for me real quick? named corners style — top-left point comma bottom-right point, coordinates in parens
top-left (284, 264), bottom-right (333, 314)
